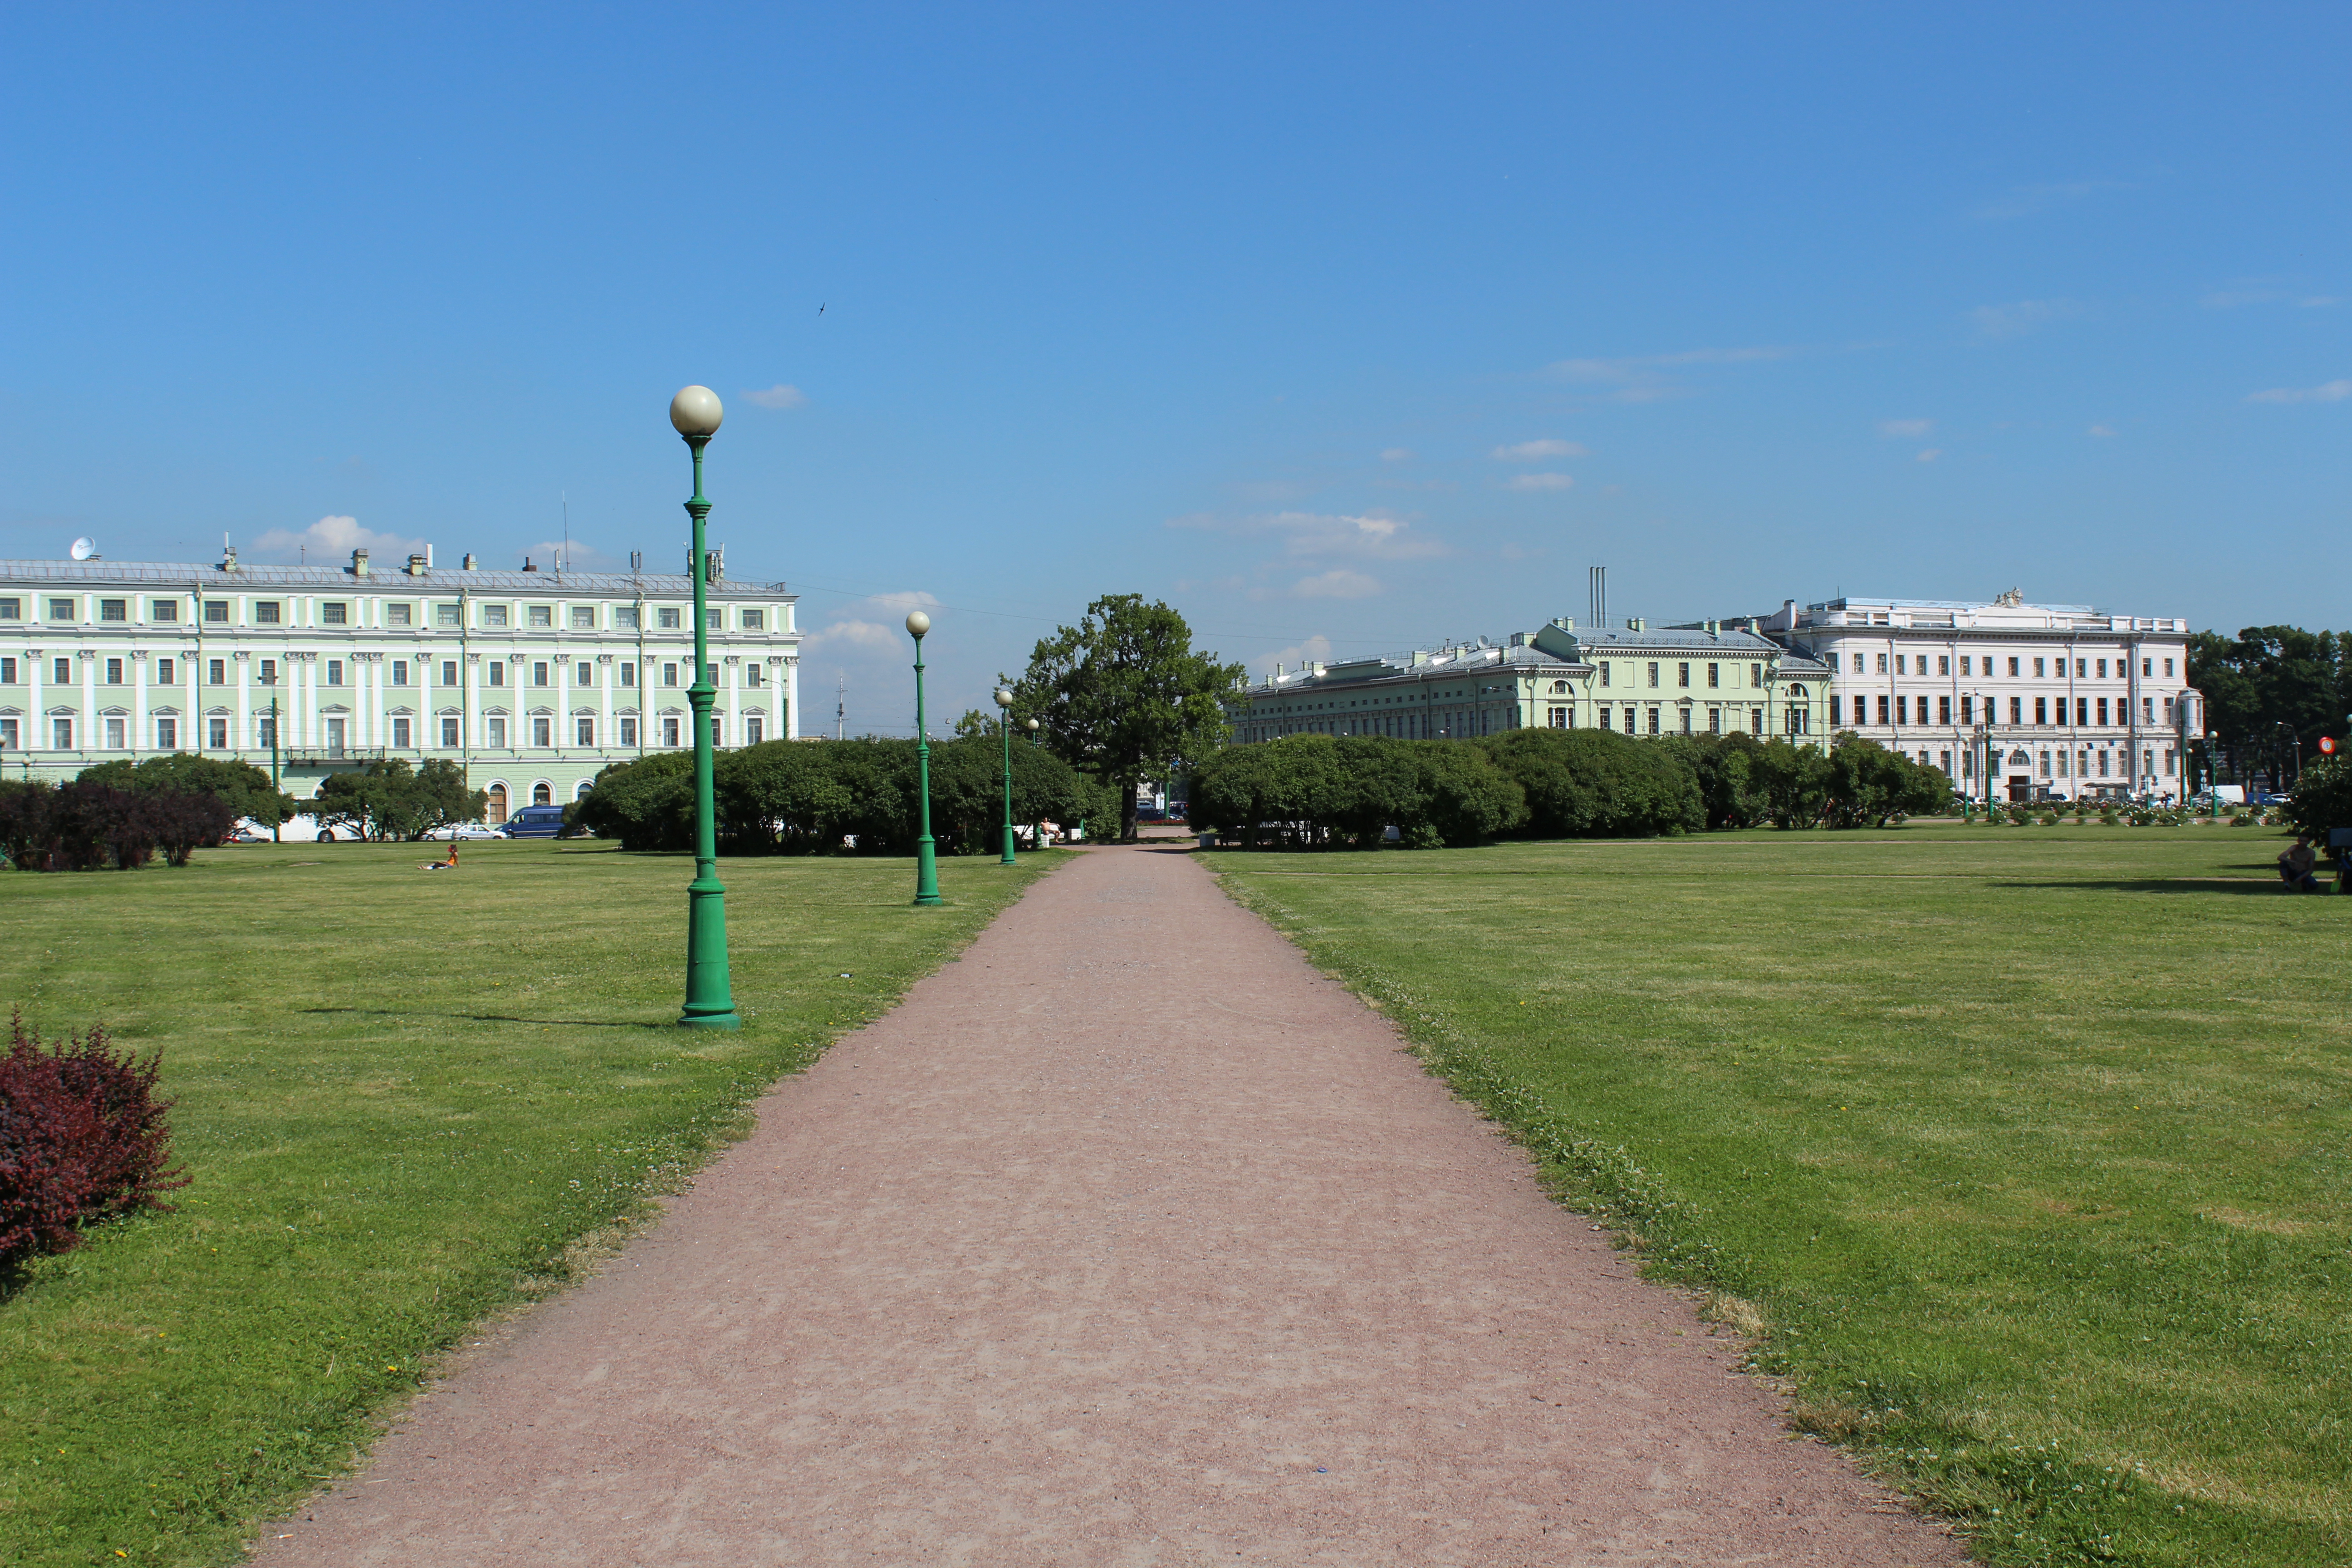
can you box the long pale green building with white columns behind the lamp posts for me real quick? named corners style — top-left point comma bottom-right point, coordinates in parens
top-left (0, 550), bottom-right (800, 823)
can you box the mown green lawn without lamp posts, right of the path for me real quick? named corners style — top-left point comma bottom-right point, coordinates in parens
top-left (1211, 825), bottom-right (2352, 1568)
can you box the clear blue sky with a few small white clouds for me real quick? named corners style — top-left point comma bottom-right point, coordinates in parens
top-left (0, 5), bottom-right (2352, 729)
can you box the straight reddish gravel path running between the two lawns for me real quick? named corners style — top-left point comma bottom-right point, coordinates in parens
top-left (261, 848), bottom-right (1964, 1568)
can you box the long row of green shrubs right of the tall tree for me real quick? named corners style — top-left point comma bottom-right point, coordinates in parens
top-left (1190, 729), bottom-right (1952, 848)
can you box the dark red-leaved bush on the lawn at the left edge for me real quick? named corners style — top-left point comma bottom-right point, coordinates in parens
top-left (0, 1011), bottom-right (188, 1267)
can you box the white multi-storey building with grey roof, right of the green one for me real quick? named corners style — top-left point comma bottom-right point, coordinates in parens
top-left (1745, 590), bottom-right (2204, 799)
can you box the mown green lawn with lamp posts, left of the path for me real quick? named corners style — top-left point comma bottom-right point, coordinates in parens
top-left (0, 842), bottom-right (1058, 1568)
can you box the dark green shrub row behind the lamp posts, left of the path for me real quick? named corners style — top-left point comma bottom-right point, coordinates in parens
top-left (564, 738), bottom-right (1120, 856)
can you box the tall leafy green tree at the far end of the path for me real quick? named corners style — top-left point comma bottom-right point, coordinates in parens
top-left (1014, 593), bottom-right (1242, 839)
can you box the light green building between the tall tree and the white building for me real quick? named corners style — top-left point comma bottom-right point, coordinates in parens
top-left (1232, 618), bottom-right (1830, 745)
